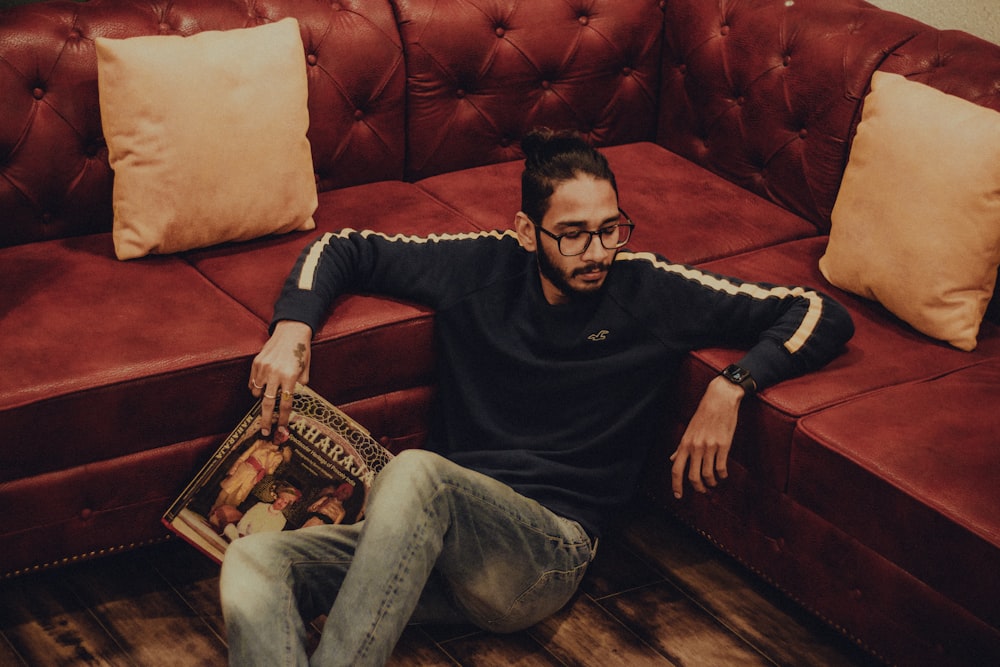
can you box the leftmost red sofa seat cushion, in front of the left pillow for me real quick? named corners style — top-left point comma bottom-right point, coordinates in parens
top-left (0, 234), bottom-right (266, 482)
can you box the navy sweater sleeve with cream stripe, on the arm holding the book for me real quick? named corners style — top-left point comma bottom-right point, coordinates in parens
top-left (271, 229), bottom-right (517, 332)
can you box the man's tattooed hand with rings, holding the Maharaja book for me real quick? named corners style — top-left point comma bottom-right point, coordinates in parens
top-left (249, 320), bottom-right (312, 436)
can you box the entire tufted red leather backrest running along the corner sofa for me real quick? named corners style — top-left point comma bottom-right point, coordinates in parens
top-left (0, 0), bottom-right (1000, 247)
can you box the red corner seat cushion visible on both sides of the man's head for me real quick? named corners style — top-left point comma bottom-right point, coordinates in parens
top-left (417, 142), bottom-right (817, 264)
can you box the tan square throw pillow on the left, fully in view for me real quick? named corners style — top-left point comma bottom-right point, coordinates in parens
top-left (97, 18), bottom-right (317, 259)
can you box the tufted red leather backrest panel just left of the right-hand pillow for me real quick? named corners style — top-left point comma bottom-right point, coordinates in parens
top-left (657, 0), bottom-right (927, 231)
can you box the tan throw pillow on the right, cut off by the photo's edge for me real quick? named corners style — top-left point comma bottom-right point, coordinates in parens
top-left (819, 72), bottom-right (1000, 350)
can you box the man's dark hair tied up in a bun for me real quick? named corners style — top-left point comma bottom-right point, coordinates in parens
top-left (521, 128), bottom-right (618, 224)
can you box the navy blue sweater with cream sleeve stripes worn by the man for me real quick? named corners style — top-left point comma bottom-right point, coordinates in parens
top-left (274, 230), bottom-right (853, 535)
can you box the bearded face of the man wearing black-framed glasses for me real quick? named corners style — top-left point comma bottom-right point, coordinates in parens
top-left (517, 175), bottom-right (621, 305)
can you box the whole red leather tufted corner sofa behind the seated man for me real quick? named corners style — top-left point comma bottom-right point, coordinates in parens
top-left (0, 0), bottom-right (1000, 665)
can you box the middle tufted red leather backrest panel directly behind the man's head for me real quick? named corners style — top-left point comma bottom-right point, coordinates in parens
top-left (395, 0), bottom-right (663, 178)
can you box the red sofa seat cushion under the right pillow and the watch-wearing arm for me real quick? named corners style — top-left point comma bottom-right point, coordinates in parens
top-left (681, 237), bottom-right (1000, 489)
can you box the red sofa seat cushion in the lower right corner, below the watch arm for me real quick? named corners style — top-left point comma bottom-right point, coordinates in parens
top-left (788, 359), bottom-right (1000, 627)
